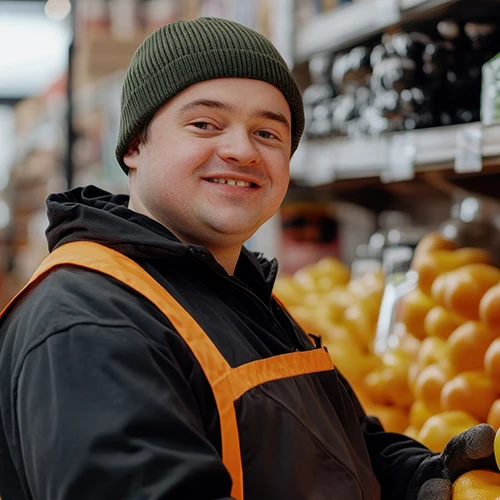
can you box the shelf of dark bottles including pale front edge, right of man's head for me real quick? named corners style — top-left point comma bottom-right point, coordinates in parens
top-left (292, 1), bottom-right (500, 186)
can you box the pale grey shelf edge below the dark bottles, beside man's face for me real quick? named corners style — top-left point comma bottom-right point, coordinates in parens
top-left (291, 123), bottom-right (500, 186)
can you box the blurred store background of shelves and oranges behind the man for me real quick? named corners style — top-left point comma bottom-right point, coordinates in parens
top-left (0, 0), bottom-right (500, 451)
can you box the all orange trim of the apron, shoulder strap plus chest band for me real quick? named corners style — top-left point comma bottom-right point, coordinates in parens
top-left (2, 241), bottom-right (333, 500)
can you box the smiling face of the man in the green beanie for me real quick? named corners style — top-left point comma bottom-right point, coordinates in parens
top-left (124, 78), bottom-right (291, 254)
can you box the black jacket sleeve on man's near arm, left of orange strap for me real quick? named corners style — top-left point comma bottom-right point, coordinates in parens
top-left (15, 324), bottom-right (235, 500)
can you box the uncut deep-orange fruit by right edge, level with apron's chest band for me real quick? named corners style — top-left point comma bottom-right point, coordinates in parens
top-left (448, 321), bottom-right (493, 373)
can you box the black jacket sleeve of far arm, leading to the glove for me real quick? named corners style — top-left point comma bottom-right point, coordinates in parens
top-left (339, 374), bottom-right (435, 500)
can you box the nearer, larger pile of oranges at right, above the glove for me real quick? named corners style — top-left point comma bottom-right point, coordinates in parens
top-left (390, 233), bottom-right (500, 451)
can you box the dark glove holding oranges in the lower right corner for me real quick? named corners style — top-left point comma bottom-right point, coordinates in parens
top-left (405, 424), bottom-right (498, 500)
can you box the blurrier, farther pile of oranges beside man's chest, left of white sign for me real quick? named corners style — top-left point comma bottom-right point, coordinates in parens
top-left (274, 257), bottom-right (384, 386)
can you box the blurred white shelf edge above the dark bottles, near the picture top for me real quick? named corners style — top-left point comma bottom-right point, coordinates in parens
top-left (295, 0), bottom-right (400, 62)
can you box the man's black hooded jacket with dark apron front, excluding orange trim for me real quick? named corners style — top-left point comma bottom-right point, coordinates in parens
top-left (0, 186), bottom-right (430, 500)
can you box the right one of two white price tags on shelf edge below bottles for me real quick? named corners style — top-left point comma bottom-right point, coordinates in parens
top-left (455, 123), bottom-right (483, 174)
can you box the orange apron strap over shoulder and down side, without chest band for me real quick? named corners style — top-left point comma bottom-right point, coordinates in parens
top-left (1, 241), bottom-right (243, 500)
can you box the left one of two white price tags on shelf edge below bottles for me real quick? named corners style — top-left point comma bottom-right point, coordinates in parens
top-left (380, 133), bottom-right (417, 183)
